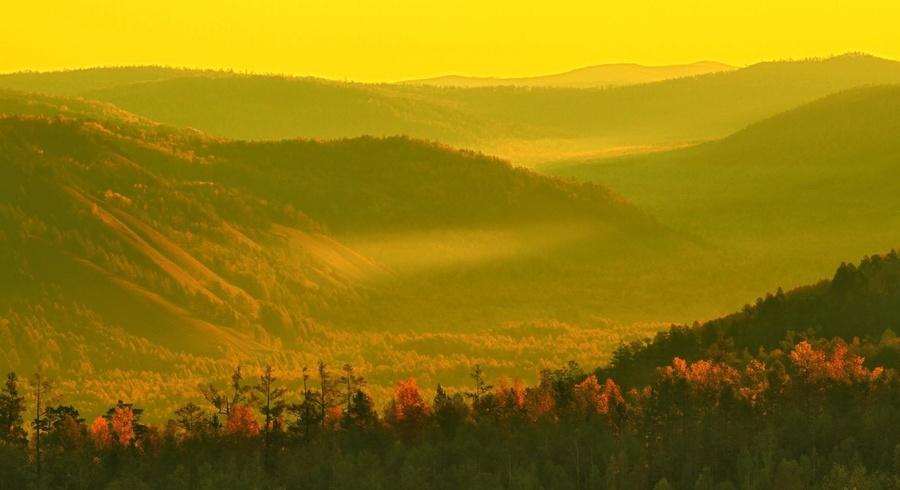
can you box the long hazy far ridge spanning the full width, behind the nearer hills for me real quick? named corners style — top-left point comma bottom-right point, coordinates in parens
top-left (0, 55), bottom-right (900, 165)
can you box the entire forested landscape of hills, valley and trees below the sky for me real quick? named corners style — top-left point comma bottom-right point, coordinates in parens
top-left (0, 50), bottom-right (900, 490)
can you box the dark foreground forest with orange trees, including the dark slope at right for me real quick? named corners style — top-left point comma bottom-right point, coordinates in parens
top-left (0, 253), bottom-right (900, 489)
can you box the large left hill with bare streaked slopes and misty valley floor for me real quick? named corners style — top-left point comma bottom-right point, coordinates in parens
top-left (0, 91), bottom-right (682, 413)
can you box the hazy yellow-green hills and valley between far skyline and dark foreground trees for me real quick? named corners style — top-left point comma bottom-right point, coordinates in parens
top-left (0, 55), bottom-right (900, 420)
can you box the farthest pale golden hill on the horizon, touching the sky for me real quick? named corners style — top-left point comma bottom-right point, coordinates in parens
top-left (403, 61), bottom-right (736, 88)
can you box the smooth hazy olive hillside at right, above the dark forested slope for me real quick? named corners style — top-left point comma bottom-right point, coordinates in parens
top-left (555, 86), bottom-right (900, 306)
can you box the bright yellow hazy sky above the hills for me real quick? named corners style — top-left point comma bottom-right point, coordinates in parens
top-left (7, 0), bottom-right (900, 81)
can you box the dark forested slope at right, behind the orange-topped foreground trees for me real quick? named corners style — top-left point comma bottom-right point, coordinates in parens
top-left (597, 251), bottom-right (900, 386)
